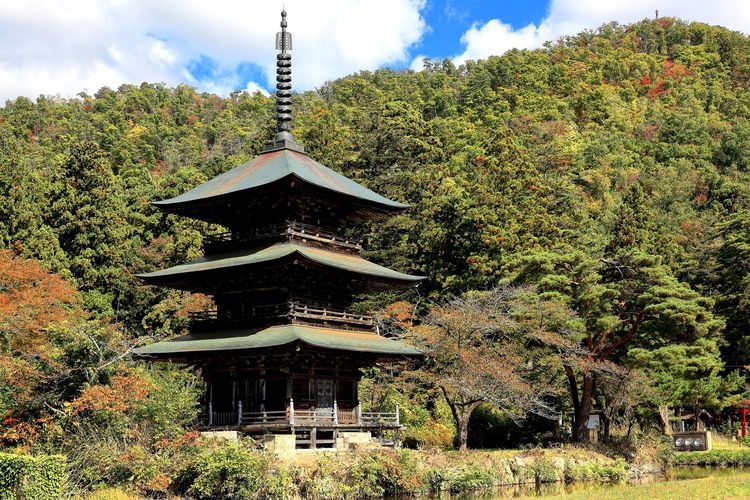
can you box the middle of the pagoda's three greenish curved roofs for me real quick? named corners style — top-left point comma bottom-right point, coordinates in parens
top-left (137, 242), bottom-right (424, 283)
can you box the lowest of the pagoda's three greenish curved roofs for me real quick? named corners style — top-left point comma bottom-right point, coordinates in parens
top-left (133, 325), bottom-right (422, 358)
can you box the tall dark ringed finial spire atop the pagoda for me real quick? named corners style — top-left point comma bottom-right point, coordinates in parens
top-left (263, 7), bottom-right (304, 152)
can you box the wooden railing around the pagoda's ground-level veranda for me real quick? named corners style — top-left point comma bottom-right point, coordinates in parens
top-left (201, 399), bottom-right (401, 428)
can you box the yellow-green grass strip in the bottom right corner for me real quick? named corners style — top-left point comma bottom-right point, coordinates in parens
top-left (546, 469), bottom-right (750, 500)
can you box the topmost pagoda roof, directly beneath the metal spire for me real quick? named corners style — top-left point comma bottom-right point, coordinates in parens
top-left (153, 149), bottom-right (409, 210)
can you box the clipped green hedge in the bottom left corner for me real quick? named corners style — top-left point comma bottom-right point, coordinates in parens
top-left (0, 453), bottom-right (65, 500)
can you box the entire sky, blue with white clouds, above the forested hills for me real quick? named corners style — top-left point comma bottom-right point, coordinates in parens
top-left (0, 0), bottom-right (750, 102)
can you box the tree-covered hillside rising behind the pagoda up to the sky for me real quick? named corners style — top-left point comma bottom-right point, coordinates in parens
top-left (0, 18), bottom-right (750, 480)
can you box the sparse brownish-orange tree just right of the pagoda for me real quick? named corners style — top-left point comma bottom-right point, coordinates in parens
top-left (414, 288), bottom-right (567, 450)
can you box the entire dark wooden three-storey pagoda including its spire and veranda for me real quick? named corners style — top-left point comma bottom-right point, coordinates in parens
top-left (136, 13), bottom-right (422, 448)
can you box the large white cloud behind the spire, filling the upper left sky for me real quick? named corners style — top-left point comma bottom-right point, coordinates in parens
top-left (0, 0), bottom-right (427, 102)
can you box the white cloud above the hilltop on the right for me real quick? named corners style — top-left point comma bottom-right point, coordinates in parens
top-left (454, 0), bottom-right (750, 63)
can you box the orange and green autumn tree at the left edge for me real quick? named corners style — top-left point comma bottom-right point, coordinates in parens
top-left (0, 251), bottom-right (138, 444)
